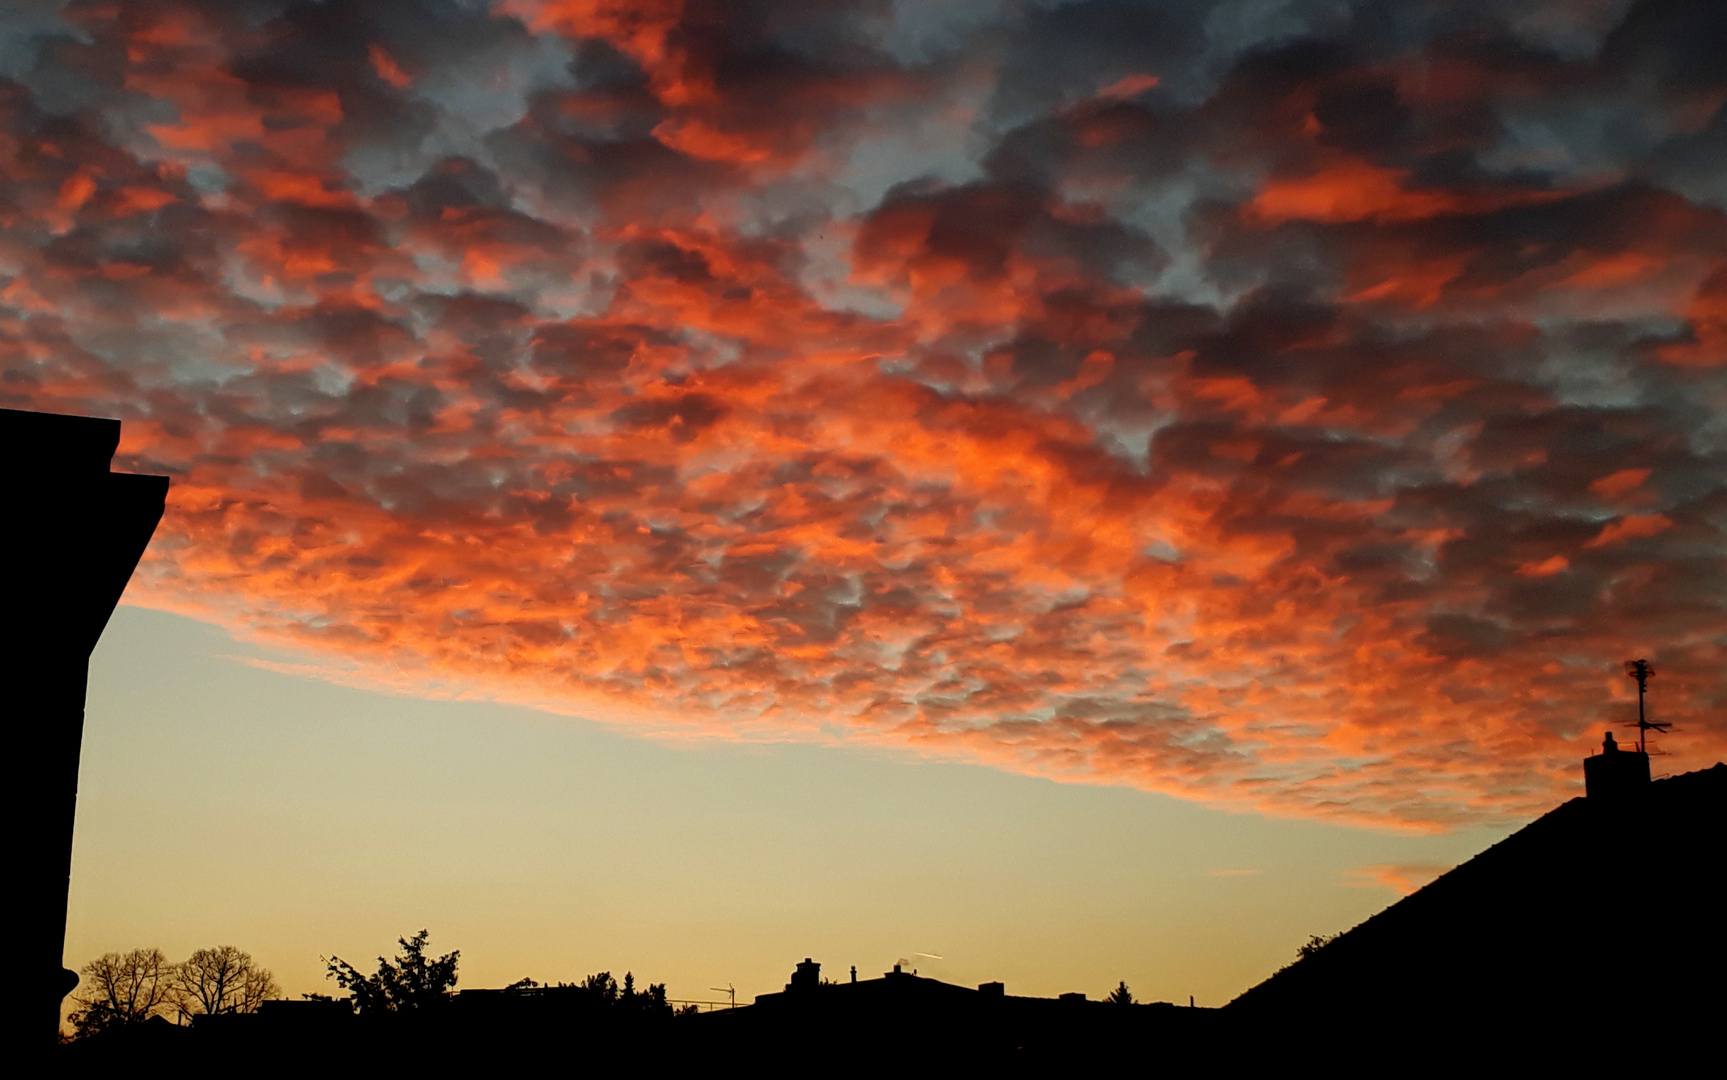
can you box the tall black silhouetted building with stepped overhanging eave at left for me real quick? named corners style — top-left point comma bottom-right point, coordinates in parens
top-left (0, 410), bottom-right (168, 1045)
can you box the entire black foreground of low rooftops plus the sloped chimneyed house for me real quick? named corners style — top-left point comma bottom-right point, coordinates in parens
top-left (64, 752), bottom-right (1727, 1075)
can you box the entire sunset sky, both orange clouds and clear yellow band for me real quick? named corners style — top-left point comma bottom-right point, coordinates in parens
top-left (0, 0), bottom-right (1727, 1004)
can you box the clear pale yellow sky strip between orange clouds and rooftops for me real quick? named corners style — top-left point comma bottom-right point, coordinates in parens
top-left (66, 607), bottom-right (1504, 1004)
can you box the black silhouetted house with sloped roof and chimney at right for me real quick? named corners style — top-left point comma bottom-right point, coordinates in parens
top-left (1223, 763), bottom-right (1727, 1064)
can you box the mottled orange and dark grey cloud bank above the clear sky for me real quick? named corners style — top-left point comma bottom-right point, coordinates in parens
top-left (0, 0), bottom-right (1727, 826)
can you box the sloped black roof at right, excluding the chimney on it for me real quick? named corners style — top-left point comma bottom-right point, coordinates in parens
top-left (1226, 764), bottom-right (1727, 1026)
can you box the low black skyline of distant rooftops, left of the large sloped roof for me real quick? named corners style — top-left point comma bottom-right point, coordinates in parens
top-left (64, 961), bottom-right (1219, 1075)
